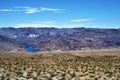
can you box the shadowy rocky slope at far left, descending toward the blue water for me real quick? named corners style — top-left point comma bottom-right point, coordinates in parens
top-left (0, 36), bottom-right (24, 52)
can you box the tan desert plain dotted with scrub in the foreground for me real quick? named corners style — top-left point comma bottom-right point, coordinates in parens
top-left (0, 52), bottom-right (120, 80)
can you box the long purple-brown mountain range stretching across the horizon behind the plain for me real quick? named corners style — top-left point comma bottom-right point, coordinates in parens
top-left (0, 27), bottom-right (120, 52)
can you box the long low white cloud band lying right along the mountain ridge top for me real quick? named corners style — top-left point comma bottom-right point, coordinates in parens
top-left (11, 23), bottom-right (118, 28)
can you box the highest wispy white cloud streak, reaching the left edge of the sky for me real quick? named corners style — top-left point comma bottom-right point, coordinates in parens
top-left (0, 7), bottom-right (64, 14)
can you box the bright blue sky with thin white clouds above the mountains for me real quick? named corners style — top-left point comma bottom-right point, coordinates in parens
top-left (0, 0), bottom-right (120, 28)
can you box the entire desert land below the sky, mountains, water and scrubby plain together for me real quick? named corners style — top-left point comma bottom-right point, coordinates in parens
top-left (0, 28), bottom-right (120, 80)
